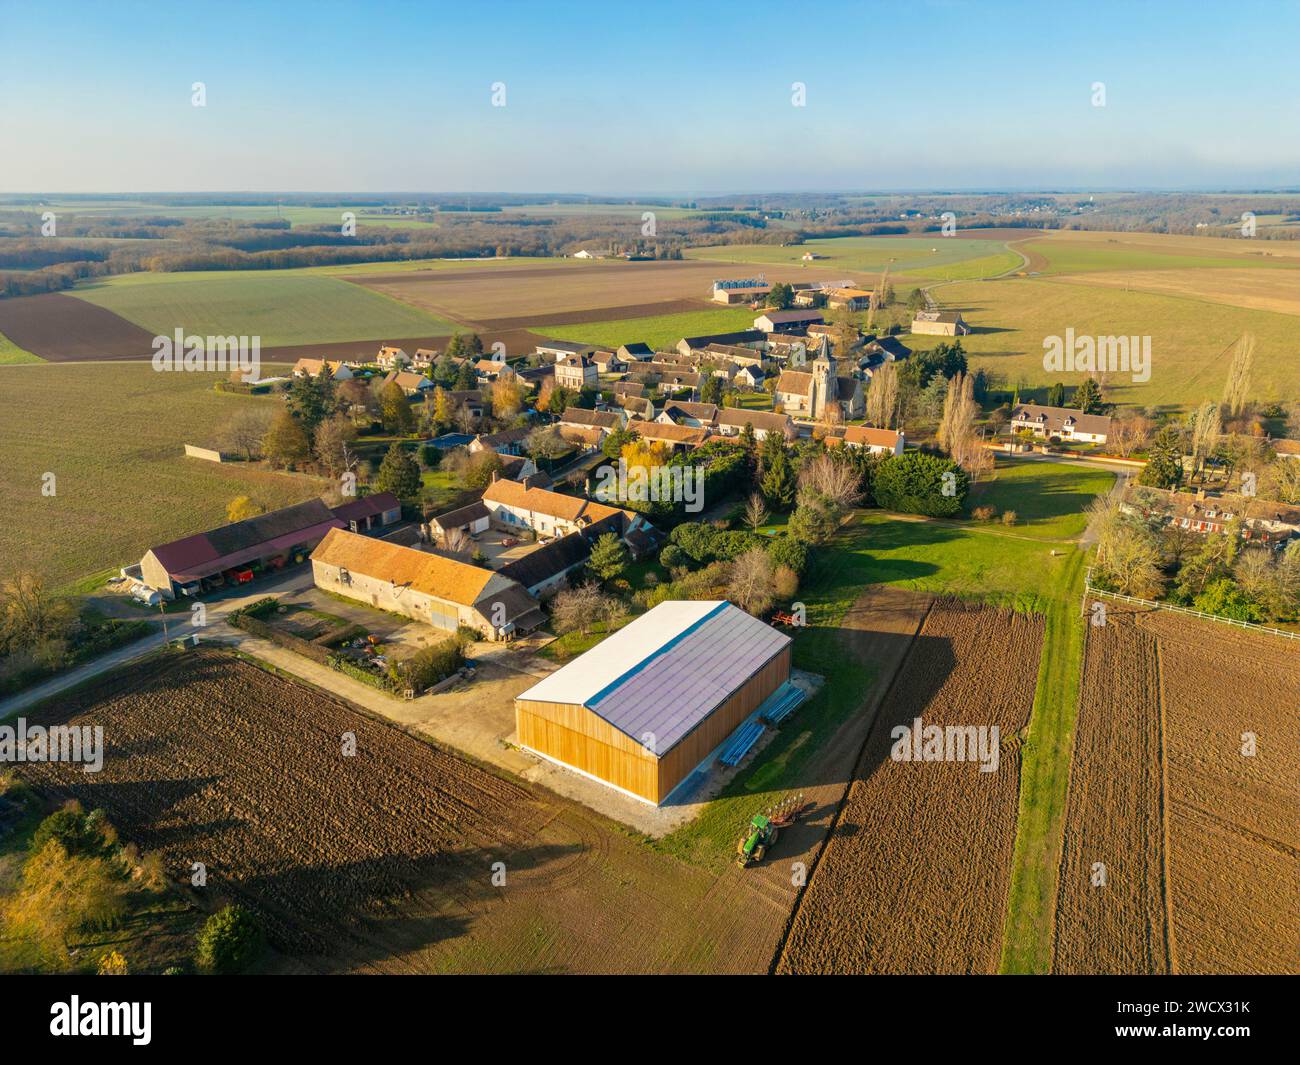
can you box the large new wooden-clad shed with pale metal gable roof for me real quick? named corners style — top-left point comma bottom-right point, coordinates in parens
top-left (515, 601), bottom-right (790, 805)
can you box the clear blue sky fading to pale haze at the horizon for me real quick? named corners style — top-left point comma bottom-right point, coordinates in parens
top-left (0, 0), bottom-right (1300, 196)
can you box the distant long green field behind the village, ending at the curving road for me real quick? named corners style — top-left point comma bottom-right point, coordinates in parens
top-left (686, 234), bottom-right (1021, 281)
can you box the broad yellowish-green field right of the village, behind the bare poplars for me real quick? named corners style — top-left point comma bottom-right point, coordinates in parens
top-left (925, 274), bottom-right (1300, 406)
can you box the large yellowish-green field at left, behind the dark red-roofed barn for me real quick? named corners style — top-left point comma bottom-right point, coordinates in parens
top-left (0, 361), bottom-right (321, 585)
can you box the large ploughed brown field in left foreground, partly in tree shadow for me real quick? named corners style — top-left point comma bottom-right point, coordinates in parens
top-left (26, 649), bottom-right (787, 973)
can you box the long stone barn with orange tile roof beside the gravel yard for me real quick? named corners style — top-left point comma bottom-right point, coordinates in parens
top-left (312, 529), bottom-right (546, 640)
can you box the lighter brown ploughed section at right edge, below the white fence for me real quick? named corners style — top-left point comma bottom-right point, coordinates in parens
top-left (1135, 611), bottom-right (1300, 974)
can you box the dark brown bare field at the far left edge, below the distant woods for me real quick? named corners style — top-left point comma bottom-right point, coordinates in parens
top-left (0, 293), bottom-right (153, 363)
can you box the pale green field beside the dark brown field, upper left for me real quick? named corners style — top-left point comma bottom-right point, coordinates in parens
top-left (70, 270), bottom-right (456, 347)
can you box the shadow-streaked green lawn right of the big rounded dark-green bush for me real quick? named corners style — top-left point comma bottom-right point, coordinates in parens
top-left (967, 459), bottom-right (1115, 540)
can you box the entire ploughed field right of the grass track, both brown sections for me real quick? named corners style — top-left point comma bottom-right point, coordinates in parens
top-left (1054, 602), bottom-right (1300, 974)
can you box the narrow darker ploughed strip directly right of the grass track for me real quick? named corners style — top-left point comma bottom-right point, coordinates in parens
top-left (1052, 616), bottom-right (1169, 974)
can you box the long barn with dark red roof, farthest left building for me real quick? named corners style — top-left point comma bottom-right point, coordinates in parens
top-left (140, 499), bottom-right (343, 599)
